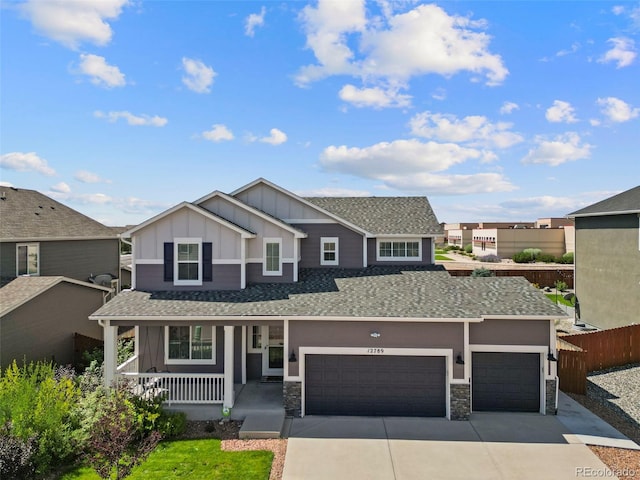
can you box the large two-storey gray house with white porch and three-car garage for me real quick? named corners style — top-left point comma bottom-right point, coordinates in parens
top-left (90, 179), bottom-right (566, 419)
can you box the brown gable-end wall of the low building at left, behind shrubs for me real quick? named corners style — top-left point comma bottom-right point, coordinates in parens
top-left (0, 282), bottom-right (105, 369)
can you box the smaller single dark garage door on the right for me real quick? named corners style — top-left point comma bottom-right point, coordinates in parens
top-left (471, 352), bottom-right (540, 412)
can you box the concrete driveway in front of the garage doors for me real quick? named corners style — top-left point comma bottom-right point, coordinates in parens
top-left (283, 413), bottom-right (616, 480)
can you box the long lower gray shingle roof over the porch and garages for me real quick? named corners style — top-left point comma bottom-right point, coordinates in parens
top-left (91, 266), bottom-right (566, 319)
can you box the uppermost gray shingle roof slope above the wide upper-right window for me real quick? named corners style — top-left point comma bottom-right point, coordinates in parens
top-left (305, 197), bottom-right (442, 235)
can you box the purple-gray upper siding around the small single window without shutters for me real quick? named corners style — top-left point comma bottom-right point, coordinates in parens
top-left (294, 223), bottom-right (362, 268)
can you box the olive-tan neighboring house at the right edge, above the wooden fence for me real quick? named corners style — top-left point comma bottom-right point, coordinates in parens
top-left (568, 186), bottom-right (640, 328)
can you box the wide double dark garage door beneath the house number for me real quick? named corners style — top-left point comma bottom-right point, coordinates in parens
top-left (305, 355), bottom-right (446, 417)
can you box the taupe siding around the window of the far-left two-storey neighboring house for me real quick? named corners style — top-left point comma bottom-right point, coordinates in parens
top-left (0, 239), bottom-right (120, 282)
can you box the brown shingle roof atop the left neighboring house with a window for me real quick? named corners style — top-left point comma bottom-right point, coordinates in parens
top-left (0, 187), bottom-right (117, 241)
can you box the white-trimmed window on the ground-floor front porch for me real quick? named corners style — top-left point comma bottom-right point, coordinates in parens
top-left (164, 325), bottom-right (216, 365)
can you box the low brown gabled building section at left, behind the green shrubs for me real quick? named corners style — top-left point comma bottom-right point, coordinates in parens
top-left (0, 276), bottom-right (111, 370)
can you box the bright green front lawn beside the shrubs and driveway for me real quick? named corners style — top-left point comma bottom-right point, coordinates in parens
top-left (59, 439), bottom-right (273, 480)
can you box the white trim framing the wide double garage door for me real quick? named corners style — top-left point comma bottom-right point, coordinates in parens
top-left (298, 346), bottom-right (453, 420)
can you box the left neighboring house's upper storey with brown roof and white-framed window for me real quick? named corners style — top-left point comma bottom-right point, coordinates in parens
top-left (0, 186), bottom-right (120, 282)
